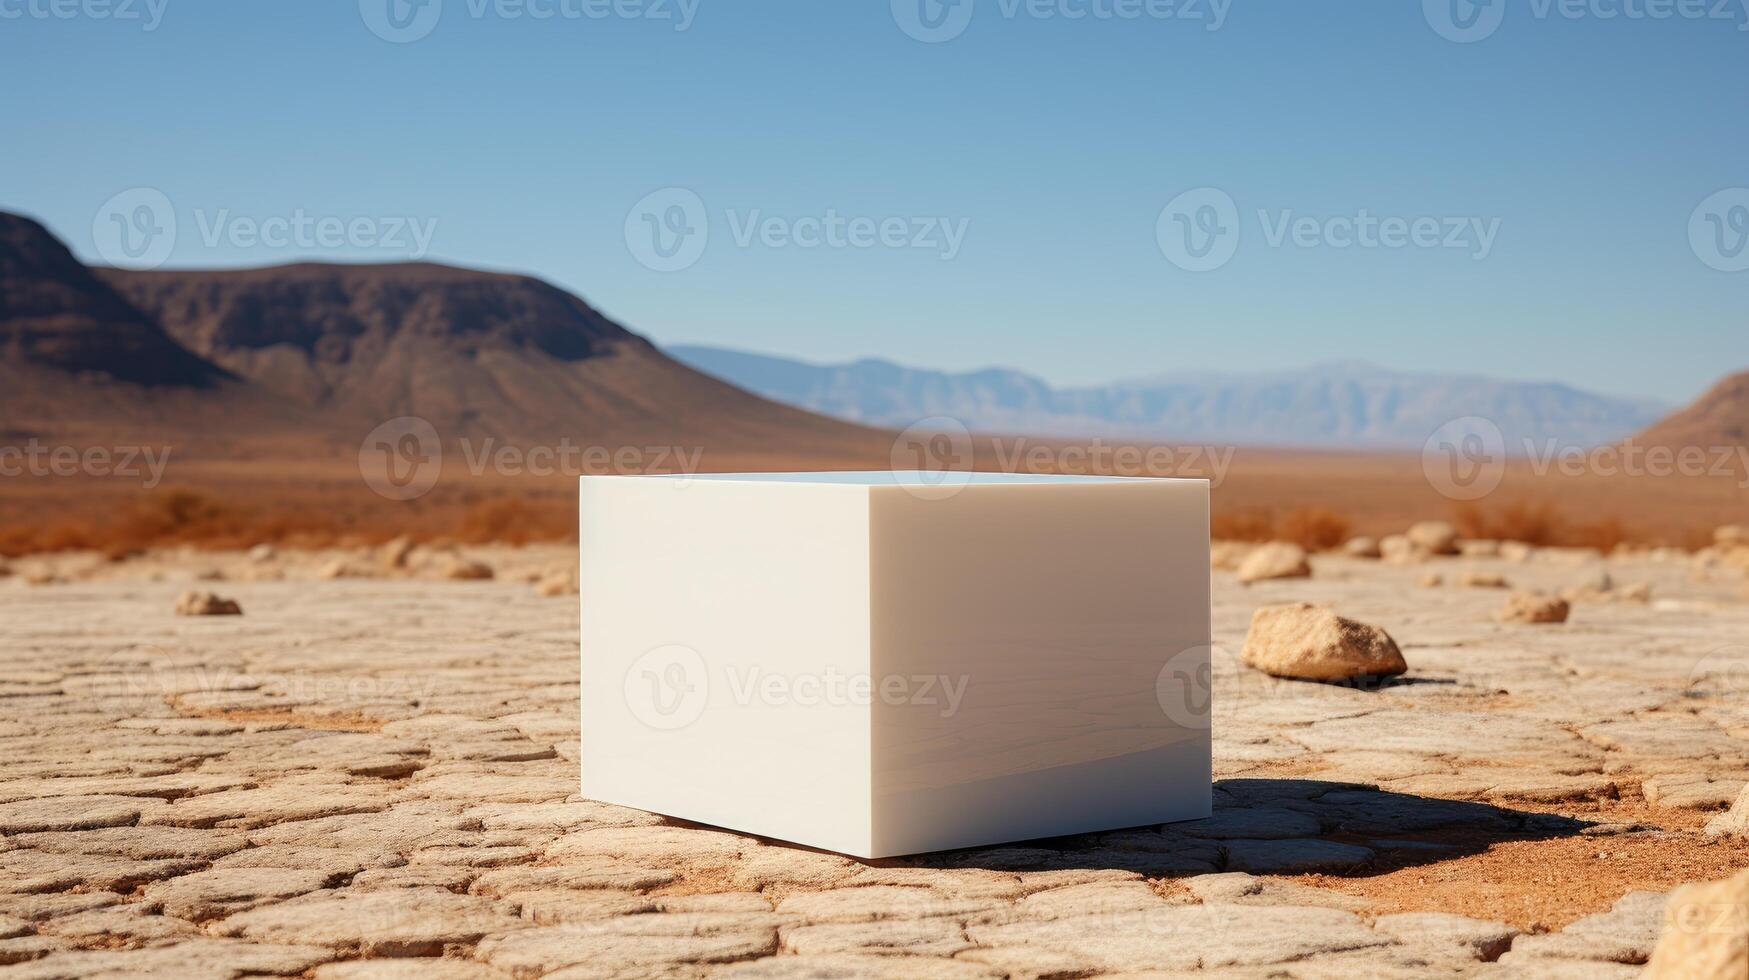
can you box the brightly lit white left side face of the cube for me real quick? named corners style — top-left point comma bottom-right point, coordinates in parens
top-left (579, 478), bottom-right (871, 854)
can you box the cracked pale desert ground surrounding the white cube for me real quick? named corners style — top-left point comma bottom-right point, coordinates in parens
top-left (0, 532), bottom-right (1749, 980)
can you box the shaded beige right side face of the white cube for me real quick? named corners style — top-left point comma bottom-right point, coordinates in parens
top-left (869, 480), bottom-right (1212, 856)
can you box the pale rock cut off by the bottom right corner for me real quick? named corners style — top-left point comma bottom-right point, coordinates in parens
top-left (1646, 870), bottom-right (1749, 980)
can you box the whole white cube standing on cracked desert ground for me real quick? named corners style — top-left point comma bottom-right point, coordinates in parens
top-left (579, 473), bottom-right (1210, 858)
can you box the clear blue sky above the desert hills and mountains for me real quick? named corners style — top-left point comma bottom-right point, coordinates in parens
top-left (0, 0), bottom-right (1749, 401)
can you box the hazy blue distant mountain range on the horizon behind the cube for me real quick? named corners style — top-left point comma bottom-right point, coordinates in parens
top-left (666, 345), bottom-right (1669, 450)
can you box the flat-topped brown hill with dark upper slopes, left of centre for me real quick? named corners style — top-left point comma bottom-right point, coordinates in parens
top-left (100, 263), bottom-right (881, 452)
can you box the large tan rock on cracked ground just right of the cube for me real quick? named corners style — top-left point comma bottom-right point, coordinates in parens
top-left (1240, 602), bottom-right (1408, 681)
